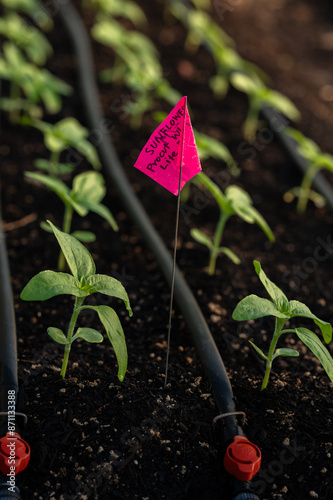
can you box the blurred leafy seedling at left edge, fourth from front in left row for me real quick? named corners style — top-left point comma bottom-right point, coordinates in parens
top-left (0, 41), bottom-right (72, 122)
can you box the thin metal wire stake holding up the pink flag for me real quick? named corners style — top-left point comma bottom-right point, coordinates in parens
top-left (164, 96), bottom-right (187, 389)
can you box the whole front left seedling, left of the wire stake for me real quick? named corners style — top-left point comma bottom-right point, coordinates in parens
top-left (21, 221), bottom-right (132, 381)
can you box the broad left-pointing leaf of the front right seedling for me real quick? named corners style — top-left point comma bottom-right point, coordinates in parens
top-left (232, 295), bottom-right (289, 321)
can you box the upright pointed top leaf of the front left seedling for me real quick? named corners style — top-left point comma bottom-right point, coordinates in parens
top-left (47, 221), bottom-right (96, 281)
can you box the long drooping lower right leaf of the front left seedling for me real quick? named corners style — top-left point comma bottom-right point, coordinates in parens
top-left (94, 306), bottom-right (127, 381)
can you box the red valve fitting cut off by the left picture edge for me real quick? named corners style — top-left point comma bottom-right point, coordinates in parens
top-left (0, 432), bottom-right (30, 475)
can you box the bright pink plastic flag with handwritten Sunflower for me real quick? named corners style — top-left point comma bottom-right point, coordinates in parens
top-left (134, 96), bottom-right (201, 195)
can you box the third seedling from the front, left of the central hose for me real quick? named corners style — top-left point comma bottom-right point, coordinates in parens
top-left (23, 116), bottom-right (101, 177)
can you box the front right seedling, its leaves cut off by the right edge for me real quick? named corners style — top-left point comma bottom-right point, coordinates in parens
top-left (232, 261), bottom-right (333, 390)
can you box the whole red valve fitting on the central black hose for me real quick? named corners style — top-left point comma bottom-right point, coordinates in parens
top-left (223, 436), bottom-right (261, 481)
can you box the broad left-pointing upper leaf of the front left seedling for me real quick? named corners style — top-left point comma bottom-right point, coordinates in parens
top-left (20, 271), bottom-right (87, 300)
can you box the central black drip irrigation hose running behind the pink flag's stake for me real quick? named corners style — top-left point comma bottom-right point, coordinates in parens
top-left (54, 0), bottom-right (258, 500)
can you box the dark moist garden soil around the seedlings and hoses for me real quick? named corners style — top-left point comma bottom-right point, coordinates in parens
top-left (0, 0), bottom-right (333, 500)
